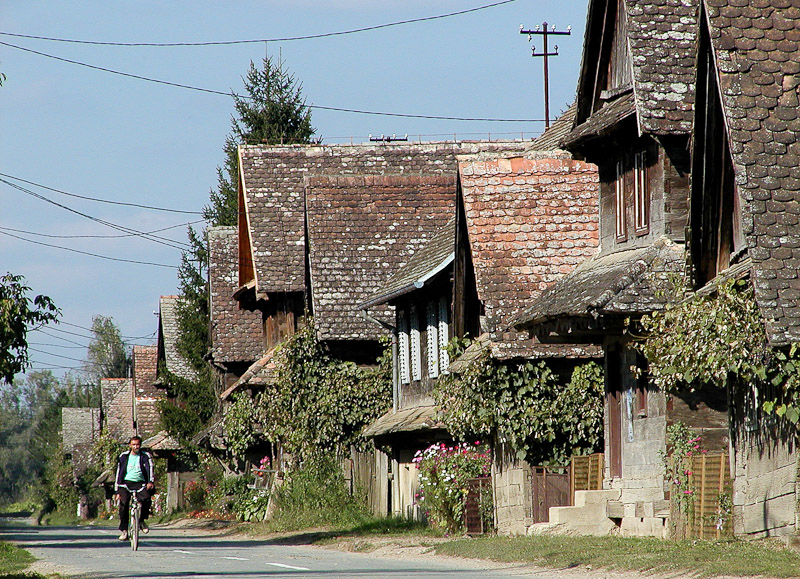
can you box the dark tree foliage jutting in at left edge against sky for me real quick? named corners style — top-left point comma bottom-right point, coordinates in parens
top-left (0, 273), bottom-right (61, 383)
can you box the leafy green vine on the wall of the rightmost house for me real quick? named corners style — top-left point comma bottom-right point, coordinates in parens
top-left (634, 280), bottom-right (800, 424)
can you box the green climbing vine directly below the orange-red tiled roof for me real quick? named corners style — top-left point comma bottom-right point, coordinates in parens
top-left (434, 346), bottom-right (603, 465)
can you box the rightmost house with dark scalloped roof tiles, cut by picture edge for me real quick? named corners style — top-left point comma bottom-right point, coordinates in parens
top-left (687, 0), bottom-right (800, 537)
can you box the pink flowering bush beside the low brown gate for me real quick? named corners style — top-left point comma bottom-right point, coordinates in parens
top-left (413, 442), bottom-right (492, 533)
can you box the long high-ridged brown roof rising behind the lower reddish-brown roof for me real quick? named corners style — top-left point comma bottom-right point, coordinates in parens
top-left (239, 141), bottom-right (530, 294)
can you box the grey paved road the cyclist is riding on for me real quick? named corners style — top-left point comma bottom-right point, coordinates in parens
top-left (0, 522), bottom-right (547, 579)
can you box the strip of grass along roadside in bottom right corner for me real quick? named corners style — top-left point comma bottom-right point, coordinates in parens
top-left (436, 535), bottom-right (800, 577)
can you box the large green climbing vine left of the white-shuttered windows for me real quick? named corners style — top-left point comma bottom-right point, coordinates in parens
top-left (225, 320), bottom-right (392, 460)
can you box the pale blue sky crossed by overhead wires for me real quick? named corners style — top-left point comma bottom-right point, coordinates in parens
top-left (0, 0), bottom-right (587, 386)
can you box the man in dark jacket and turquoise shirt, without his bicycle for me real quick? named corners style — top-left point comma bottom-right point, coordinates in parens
top-left (114, 436), bottom-right (155, 541)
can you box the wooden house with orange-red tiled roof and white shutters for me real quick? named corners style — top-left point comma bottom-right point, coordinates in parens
top-left (361, 134), bottom-right (599, 533)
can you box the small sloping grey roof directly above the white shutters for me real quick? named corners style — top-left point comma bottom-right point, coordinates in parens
top-left (358, 218), bottom-right (456, 309)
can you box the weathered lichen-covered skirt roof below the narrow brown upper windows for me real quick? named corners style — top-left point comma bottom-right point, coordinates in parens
top-left (511, 237), bottom-right (685, 327)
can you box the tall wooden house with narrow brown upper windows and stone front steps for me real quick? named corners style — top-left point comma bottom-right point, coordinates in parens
top-left (517, 0), bottom-right (728, 536)
